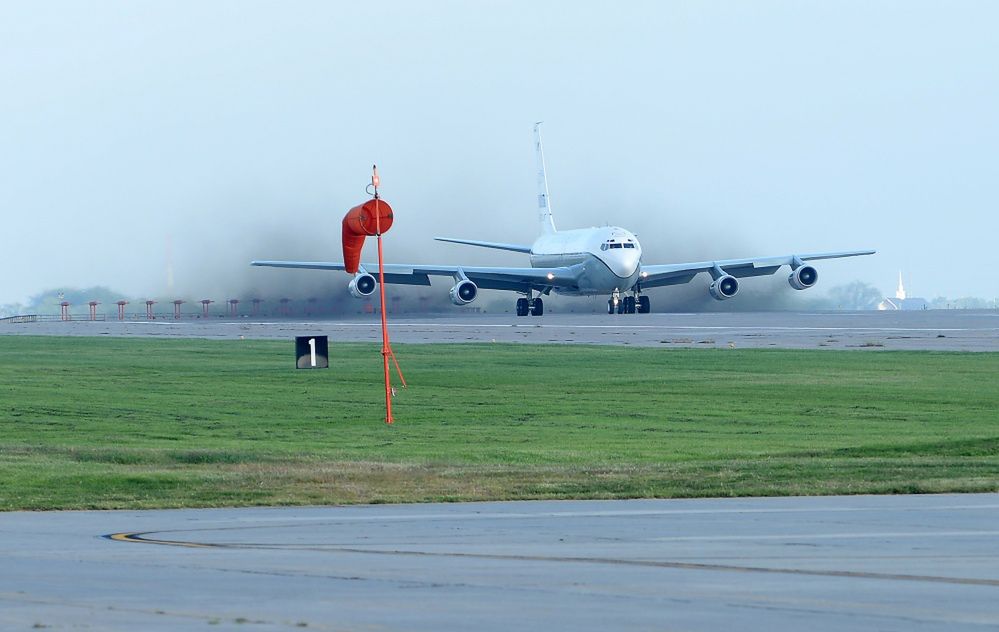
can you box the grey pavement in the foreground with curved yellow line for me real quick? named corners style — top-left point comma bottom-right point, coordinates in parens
top-left (0, 494), bottom-right (999, 631)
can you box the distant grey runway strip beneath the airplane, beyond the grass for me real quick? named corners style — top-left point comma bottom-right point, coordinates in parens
top-left (0, 310), bottom-right (999, 351)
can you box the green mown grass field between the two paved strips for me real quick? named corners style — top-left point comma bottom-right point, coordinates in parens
top-left (0, 336), bottom-right (999, 510)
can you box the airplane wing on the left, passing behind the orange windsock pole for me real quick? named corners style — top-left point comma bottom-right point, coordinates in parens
top-left (250, 261), bottom-right (581, 292)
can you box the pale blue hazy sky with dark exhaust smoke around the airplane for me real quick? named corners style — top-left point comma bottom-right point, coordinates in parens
top-left (0, 0), bottom-right (999, 304)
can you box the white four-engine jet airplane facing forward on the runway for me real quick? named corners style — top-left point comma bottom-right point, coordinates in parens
top-left (251, 123), bottom-right (875, 316)
